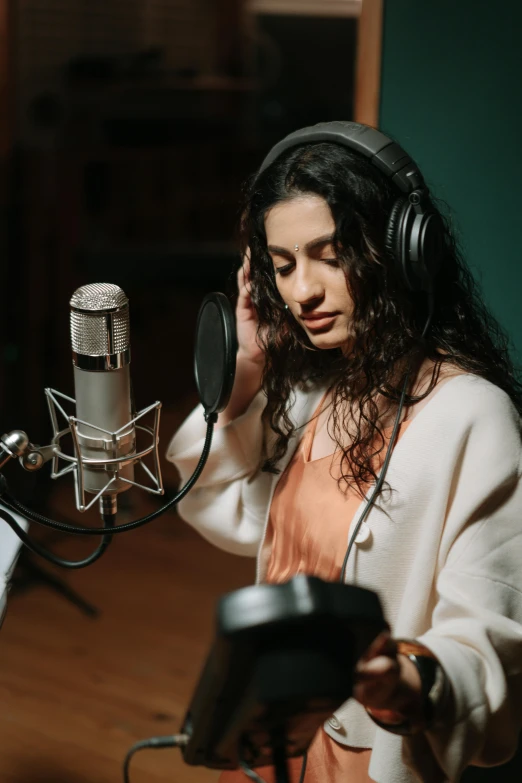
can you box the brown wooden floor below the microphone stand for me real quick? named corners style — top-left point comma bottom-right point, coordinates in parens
top-left (0, 402), bottom-right (254, 783)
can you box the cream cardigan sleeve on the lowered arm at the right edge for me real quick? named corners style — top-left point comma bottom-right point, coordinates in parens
top-left (403, 389), bottom-right (522, 783)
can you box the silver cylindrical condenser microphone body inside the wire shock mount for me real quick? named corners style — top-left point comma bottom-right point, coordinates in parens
top-left (70, 283), bottom-right (136, 514)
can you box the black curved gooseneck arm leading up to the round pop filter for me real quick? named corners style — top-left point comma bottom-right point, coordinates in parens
top-left (2, 414), bottom-right (217, 543)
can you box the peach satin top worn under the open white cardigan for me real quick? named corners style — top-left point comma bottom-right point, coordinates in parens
top-left (219, 400), bottom-right (408, 783)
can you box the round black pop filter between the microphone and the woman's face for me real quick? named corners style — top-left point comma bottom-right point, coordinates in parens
top-left (194, 292), bottom-right (237, 419)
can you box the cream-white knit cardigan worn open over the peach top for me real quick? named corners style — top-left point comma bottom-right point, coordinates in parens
top-left (167, 375), bottom-right (522, 783)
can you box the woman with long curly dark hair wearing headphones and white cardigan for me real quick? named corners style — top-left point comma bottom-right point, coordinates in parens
top-left (168, 124), bottom-right (522, 783)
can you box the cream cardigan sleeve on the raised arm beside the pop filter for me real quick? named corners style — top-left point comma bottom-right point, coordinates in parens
top-left (167, 392), bottom-right (273, 557)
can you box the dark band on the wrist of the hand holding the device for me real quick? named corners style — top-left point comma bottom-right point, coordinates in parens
top-left (366, 639), bottom-right (449, 736)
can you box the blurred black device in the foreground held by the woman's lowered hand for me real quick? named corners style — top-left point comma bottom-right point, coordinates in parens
top-left (181, 574), bottom-right (388, 769)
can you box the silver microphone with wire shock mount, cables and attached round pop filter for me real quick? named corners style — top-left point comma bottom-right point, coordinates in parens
top-left (0, 283), bottom-right (233, 552)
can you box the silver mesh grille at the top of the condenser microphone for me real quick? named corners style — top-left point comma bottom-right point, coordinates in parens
top-left (70, 283), bottom-right (130, 356)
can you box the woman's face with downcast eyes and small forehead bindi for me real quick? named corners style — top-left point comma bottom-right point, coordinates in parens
top-left (265, 195), bottom-right (353, 349)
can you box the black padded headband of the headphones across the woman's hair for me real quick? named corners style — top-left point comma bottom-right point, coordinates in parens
top-left (258, 122), bottom-right (426, 195)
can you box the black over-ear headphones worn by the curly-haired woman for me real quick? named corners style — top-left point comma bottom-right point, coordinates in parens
top-left (258, 122), bottom-right (444, 293)
